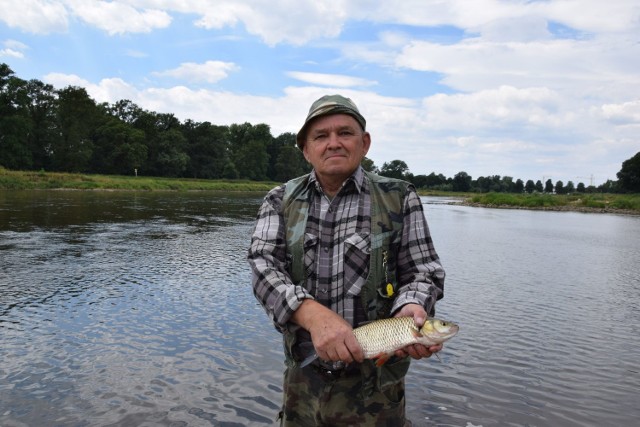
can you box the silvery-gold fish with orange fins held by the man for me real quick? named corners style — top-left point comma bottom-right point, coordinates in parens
top-left (300, 317), bottom-right (460, 367)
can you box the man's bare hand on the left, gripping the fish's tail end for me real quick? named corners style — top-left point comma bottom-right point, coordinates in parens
top-left (291, 299), bottom-right (364, 363)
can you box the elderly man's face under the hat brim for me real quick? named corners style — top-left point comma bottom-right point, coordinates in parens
top-left (302, 114), bottom-right (371, 184)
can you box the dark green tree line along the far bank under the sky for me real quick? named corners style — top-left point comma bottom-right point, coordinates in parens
top-left (0, 64), bottom-right (640, 193)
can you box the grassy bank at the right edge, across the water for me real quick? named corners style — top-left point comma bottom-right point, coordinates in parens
top-left (466, 193), bottom-right (640, 214)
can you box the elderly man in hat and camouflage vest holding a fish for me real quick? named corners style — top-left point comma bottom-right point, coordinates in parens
top-left (248, 95), bottom-right (445, 426)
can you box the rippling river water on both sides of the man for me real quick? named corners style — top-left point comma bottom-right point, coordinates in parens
top-left (0, 191), bottom-right (640, 426)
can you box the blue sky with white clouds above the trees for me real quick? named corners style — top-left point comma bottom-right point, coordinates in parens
top-left (0, 0), bottom-right (640, 186)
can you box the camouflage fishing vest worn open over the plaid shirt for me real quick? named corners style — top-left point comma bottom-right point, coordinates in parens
top-left (282, 171), bottom-right (409, 387)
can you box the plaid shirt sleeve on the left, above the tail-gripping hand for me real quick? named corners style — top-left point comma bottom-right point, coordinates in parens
top-left (247, 186), bottom-right (313, 330)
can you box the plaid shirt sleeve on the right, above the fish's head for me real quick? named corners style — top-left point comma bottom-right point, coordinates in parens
top-left (392, 187), bottom-right (445, 316)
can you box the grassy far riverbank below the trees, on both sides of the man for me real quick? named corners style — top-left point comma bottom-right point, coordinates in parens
top-left (0, 168), bottom-right (640, 215)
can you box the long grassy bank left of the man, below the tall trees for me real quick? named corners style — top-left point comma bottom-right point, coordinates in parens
top-left (0, 168), bottom-right (276, 192)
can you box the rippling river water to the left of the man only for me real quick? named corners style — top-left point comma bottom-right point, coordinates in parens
top-left (0, 192), bottom-right (282, 426)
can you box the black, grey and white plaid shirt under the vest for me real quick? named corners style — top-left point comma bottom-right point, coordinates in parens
top-left (248, 168), bottom-right (445, 329)
